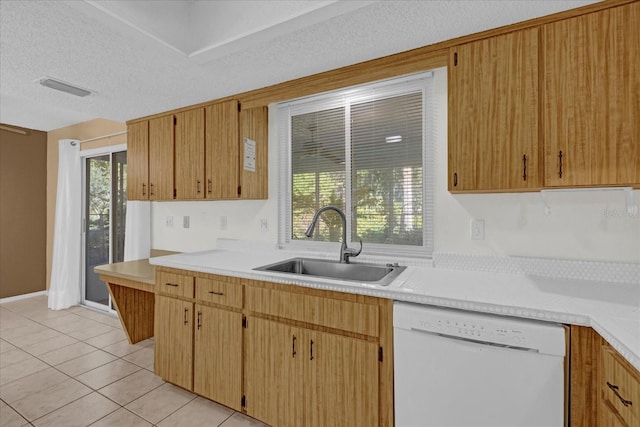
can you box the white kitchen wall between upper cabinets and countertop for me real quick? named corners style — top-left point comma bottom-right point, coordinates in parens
top-left (152, 68), bottom-right (640, 263)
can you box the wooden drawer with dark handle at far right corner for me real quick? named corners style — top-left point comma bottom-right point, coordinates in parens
top-left (600, 345), bottom-right (640, 426)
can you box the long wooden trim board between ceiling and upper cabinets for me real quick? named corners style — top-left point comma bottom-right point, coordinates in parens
top-left (127, 0), bottom-right (637, 124)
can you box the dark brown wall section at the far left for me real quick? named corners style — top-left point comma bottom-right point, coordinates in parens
top-left (0, 129), bottom-right (47, 298)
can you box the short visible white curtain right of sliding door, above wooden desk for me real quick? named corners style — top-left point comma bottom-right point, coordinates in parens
top-left (124, 200), bottom-right (151, 261)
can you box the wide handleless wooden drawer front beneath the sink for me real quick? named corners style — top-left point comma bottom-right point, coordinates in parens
top-left (246, 286), bottom-right (380, 337)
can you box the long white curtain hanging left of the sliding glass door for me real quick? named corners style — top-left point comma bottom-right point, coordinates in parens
top-left (49, 139), bottom-right (82, 310)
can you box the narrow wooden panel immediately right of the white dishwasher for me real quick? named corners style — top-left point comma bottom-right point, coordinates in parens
top-left (569, 325), bottom-right (602, 427)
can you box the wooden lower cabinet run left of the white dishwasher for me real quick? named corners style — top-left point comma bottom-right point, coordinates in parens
top-left (155, 267), bottom-right (393, 427)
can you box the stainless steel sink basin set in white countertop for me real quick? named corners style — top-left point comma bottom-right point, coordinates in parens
top-left (254, 258), bottom-right (407, 286)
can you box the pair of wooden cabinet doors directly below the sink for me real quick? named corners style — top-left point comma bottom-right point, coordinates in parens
top-left (245, 317), bottom-right (379, 427)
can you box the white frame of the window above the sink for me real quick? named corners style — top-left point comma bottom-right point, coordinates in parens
top-left (276, 71), bottom-right (436, 258)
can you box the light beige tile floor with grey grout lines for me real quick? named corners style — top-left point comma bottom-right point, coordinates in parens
top-left (0, 296), bottom-right (264, 427)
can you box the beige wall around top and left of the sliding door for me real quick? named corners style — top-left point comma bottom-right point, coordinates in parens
top-left (46, 119), bottom-right (127, 289)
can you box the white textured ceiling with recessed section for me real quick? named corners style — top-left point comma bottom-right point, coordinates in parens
top-left (0, 0), bottom-right (594, 131)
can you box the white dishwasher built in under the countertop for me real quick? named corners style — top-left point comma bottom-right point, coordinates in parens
top-left (393, 302), bottom-right (566, 427)
